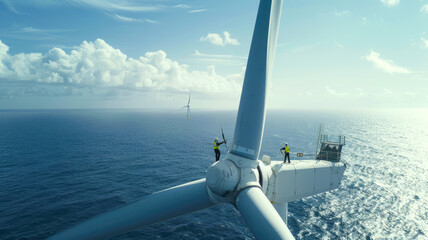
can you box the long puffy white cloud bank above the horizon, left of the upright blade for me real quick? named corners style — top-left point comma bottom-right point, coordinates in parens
top-left (0, 39), bottom-right (243, 93)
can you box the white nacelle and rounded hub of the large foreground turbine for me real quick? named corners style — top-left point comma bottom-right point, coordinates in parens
top-left (206, 152), bottom-right (346, 205)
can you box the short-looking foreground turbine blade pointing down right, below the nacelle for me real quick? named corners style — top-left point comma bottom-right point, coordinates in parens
top-left (236, 187), bottom-right (294, 240)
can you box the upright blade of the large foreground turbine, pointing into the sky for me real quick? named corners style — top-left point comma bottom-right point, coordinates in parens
top-left (231, 0), bottom-right (282, 160)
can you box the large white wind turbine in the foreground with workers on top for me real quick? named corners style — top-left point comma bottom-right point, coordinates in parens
top-left (50, 0), bottom-right (345, 240)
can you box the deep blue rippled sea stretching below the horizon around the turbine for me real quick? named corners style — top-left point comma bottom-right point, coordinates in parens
top-left (0, 109), bottom-right (428, 239)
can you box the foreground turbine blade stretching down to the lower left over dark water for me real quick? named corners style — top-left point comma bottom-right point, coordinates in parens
top-left (49, 179), bottom-right (214, 240)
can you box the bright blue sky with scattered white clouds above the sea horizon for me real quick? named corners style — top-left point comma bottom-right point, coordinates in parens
top-left (0, 0), bottom-right (428, 110)
